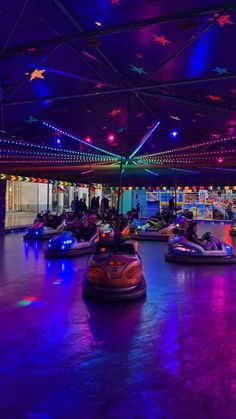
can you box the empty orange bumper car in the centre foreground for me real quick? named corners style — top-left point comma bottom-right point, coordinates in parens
top-left (83, 242), bottom-right (146, 301)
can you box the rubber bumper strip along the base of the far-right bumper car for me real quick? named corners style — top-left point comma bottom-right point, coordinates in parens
top-left (165, 253), bottom-right (236, 265)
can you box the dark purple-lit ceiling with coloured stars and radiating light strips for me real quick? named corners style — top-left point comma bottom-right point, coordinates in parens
top-left (0, 0), bottom-right (236, 186)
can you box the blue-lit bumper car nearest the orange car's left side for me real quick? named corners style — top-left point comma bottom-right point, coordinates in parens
top-left (45, 231), bottom-right (99, 258)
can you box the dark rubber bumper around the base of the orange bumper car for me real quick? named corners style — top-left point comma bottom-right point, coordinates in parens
top-left (83, 276), bottom-right (146, 301)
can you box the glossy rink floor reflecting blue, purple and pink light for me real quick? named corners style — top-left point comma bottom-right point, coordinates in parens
top-left (0, 225), bottom-right (236, 419)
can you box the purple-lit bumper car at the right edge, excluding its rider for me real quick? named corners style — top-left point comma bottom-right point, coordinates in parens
top-left (165, 233), bottom-right (236, 264)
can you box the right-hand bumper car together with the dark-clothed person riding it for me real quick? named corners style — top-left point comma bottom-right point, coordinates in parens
top-left (165, 222), bottom-right (236, 264)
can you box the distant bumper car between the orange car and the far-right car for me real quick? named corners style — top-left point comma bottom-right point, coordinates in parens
top-left (131, 220), bottom-right (177, 242)
